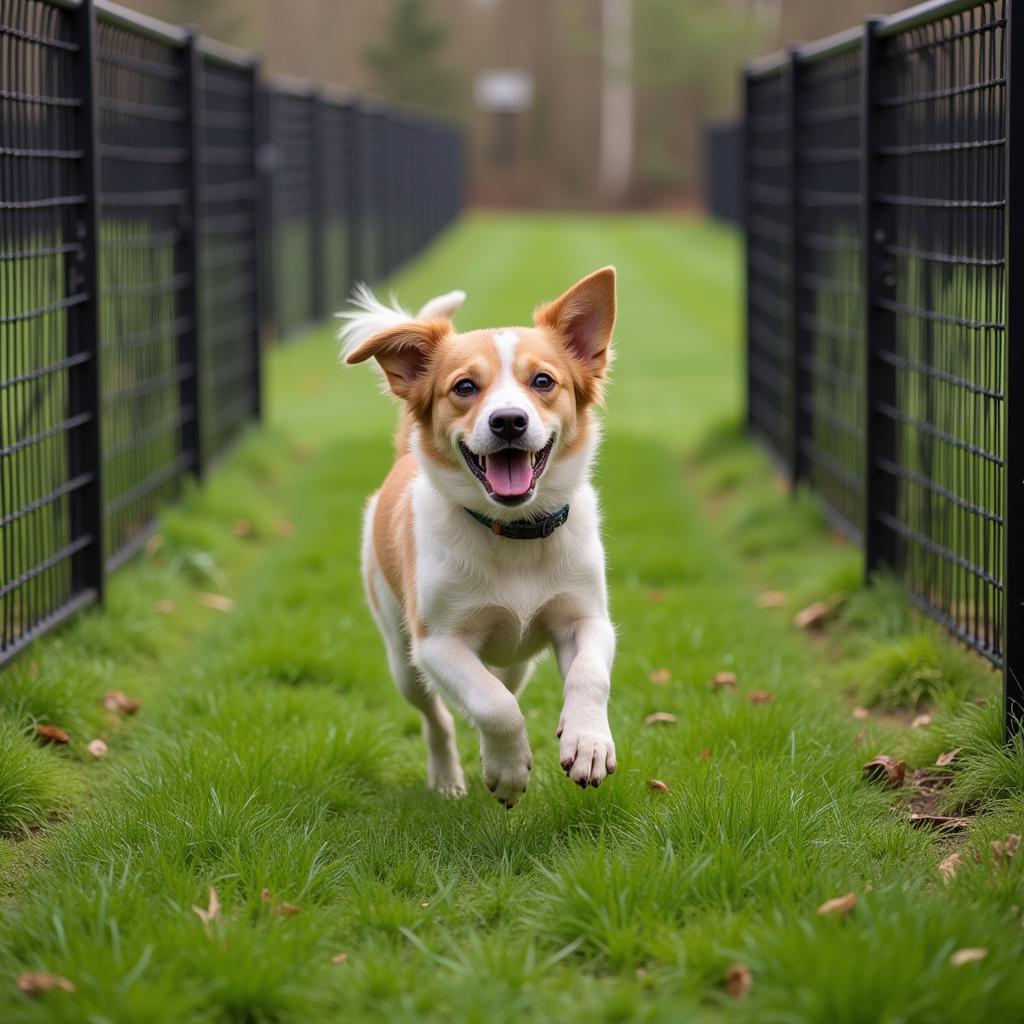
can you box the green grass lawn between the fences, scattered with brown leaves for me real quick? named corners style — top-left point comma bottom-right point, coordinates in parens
top-left (0, 215), bottom-right (1024, 1024)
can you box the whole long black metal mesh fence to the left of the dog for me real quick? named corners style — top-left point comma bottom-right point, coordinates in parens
top-left (0, 0), bottom-right (462, 664)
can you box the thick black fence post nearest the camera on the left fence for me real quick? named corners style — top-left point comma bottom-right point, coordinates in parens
top-left (65, 0), bottom-right (106, 601)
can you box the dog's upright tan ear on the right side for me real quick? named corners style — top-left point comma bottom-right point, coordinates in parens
top-left (534, 266), bottom-right (615, 379)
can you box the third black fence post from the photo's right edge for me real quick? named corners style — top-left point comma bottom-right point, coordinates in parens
top-left (785, 49), bottom-right (811, 487)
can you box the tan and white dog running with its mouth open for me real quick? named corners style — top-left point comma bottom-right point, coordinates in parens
top-left (339, 267), bottom-right (615, 808)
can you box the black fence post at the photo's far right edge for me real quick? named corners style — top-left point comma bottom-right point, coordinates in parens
top-left (1002, 4), bottom-right (1024, 742)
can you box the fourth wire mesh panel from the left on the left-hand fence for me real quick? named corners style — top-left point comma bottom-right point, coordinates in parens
top-left (270, 89), bottom-right (317, 338)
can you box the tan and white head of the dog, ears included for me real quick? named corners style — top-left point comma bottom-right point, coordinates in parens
top-left (346, 267), bottom-right (615, 518)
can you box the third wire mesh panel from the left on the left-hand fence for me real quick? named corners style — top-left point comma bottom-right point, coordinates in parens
top-left (198, 55), bottom-right (260, 457)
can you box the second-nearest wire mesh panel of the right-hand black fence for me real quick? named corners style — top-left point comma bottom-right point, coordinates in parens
top-left (794, 43), bottom-right (865, 538)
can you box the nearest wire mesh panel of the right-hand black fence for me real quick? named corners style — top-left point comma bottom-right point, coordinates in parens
top-left (871, 0), bottom-right (1007, 663)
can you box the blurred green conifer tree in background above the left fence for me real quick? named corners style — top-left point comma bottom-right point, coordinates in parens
top-left (362, 0), bottom-right (459, 112)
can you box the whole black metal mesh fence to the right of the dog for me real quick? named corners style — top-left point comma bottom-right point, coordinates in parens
top-left (743, 0), bottom-right (1024, 731)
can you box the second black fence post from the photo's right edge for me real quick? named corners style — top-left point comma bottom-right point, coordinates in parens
top-left (860, 18), bottom-right (898, 577)
